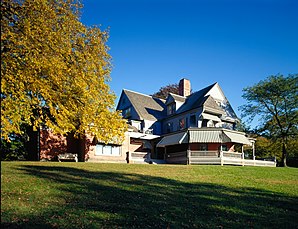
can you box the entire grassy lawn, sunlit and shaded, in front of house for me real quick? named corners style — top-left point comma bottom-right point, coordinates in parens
top-left (1, 162), bottom-right (298, 228)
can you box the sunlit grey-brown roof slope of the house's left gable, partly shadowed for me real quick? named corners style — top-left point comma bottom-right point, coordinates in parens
top-left (123, 89), bottom-right (166, 121)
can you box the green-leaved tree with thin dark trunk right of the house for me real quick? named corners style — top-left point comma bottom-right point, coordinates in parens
top-left (241, 74), bottom-right (298, 166)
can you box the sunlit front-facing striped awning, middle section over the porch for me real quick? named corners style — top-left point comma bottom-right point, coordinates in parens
top-left (189, 129), bottom-right (229, 143)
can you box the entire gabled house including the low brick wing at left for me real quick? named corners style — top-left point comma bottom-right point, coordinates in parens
top-left (38, 79), bottom-right (276, 166)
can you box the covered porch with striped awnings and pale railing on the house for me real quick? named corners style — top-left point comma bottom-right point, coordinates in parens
top-left (157, 128), bottom-right (276, 167)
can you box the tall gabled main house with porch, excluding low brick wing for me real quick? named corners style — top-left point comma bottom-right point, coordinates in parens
top-left (117, 79), bottom-right (275, 166)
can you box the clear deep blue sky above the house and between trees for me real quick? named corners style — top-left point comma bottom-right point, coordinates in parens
top-left (81, 0), bottom-right (298, 116)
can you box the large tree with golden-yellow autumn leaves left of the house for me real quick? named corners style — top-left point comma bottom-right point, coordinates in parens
top-left (1, 0), bottom-right (126, 148)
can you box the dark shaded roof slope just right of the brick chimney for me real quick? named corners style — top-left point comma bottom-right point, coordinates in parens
top-left (176, 83), bottom-right (218, 114)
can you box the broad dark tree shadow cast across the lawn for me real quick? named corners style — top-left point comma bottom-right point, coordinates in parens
top-left (1, 166), bottom-right (297, 228)
